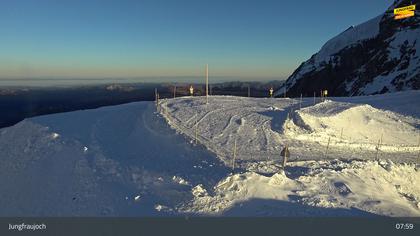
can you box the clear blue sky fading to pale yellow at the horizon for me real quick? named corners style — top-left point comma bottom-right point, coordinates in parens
top-left (0, 0), bottom-right (392, 82)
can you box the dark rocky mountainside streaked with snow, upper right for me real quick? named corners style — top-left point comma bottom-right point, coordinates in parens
top-left (276, 0), bottom-right (420, 96)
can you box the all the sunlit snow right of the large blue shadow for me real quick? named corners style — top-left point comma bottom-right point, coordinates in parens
top-left (161, 91), bottom-right (420, 216)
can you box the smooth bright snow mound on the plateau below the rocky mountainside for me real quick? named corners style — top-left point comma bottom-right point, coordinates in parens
top-left (289, 101), bottom-right (420, 147)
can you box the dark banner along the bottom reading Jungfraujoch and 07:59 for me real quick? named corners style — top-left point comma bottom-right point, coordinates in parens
top-left (0, 217), bottom-right (420, 236)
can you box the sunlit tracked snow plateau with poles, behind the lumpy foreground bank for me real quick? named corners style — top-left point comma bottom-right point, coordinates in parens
top-left (162, 92), bottom-right (420, 165)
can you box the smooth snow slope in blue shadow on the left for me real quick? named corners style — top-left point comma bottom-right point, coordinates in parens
top-left (0, 102), bottom-right (227, 216)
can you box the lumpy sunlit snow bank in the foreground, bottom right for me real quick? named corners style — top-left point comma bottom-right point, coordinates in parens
top-left (182, 160), bottom-right (420, 216)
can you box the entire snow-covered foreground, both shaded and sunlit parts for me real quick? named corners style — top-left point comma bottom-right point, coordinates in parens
top-left (0, 91), bottom-right (420, 216)
